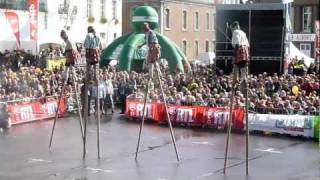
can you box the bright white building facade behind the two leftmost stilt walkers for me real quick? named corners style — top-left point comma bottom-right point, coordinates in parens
top-left (0, 0), bottom-right (122, 51)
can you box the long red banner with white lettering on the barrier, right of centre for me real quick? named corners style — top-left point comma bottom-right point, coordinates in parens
top-left (126, 100), bottom-right (244, 130)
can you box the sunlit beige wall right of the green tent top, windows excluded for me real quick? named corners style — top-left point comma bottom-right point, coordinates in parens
top-left (163, 2), bottom-right (215, 61)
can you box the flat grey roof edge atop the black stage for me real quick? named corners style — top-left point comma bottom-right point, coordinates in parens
top-left (216, 3), bottom-right (284, 11)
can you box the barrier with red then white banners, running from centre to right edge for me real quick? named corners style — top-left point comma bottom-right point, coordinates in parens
top-left (126, 99), bottom-right (320, 138)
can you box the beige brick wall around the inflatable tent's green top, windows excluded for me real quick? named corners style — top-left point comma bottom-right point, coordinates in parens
top-left (122, 0), bottom-right (215, 61)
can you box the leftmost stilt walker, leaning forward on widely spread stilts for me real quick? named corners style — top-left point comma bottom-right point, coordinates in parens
top-left (49, 30), bottom-right (84, 148)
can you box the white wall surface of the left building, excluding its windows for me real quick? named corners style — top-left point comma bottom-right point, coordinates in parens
top-left (0, 0), bottom-right (122, 52)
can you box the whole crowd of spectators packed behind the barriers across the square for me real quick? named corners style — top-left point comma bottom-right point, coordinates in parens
top-left (0, 49), bottom-right (320, 114)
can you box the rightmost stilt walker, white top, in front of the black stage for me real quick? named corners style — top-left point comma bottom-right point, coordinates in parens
top-left (223, 21), bottom-right (249, 175)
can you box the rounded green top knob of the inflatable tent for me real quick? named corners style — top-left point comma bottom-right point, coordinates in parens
top-left (132, 6), bottom-right (159, 31)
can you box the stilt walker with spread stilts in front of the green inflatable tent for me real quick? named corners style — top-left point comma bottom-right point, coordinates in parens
top-left (135, 23), bottom-right (180, 162)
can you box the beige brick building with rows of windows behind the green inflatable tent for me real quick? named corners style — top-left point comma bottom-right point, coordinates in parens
top-left (122, 0), bottom-right (215, 61)
